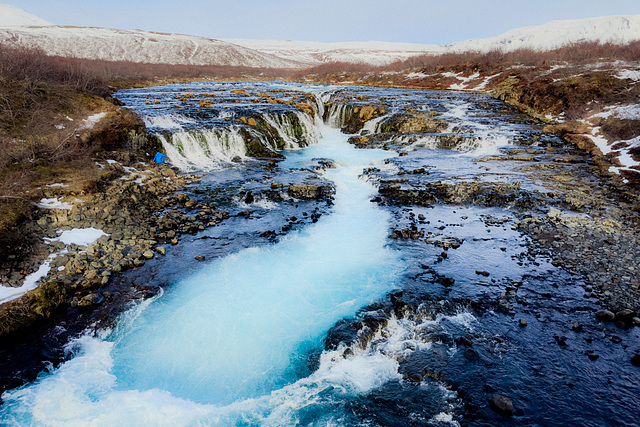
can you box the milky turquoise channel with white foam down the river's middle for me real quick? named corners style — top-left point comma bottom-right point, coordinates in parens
top-left (1, 123), bottom-right (402, 425)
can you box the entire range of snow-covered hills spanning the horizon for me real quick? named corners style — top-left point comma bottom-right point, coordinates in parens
top-left (0, 4), bottom-right (640, 68)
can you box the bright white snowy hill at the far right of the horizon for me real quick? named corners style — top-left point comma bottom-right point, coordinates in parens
top-left (445, 15), bottom-right (640, 52)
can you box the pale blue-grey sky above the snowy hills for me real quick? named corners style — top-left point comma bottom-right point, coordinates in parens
top-left (10, 0), bottom-right (640, 44)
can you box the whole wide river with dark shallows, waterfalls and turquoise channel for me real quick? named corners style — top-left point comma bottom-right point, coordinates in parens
top-left (0, 82), bottom-right (639, 426)
